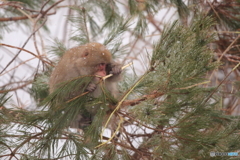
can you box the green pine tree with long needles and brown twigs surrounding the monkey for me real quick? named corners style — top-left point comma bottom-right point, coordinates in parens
top-left (0, 0), bottom-right (240, 160)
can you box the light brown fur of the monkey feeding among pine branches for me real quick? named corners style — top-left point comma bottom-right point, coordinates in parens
top-left (49, 42), bottom-right (121, 128)
